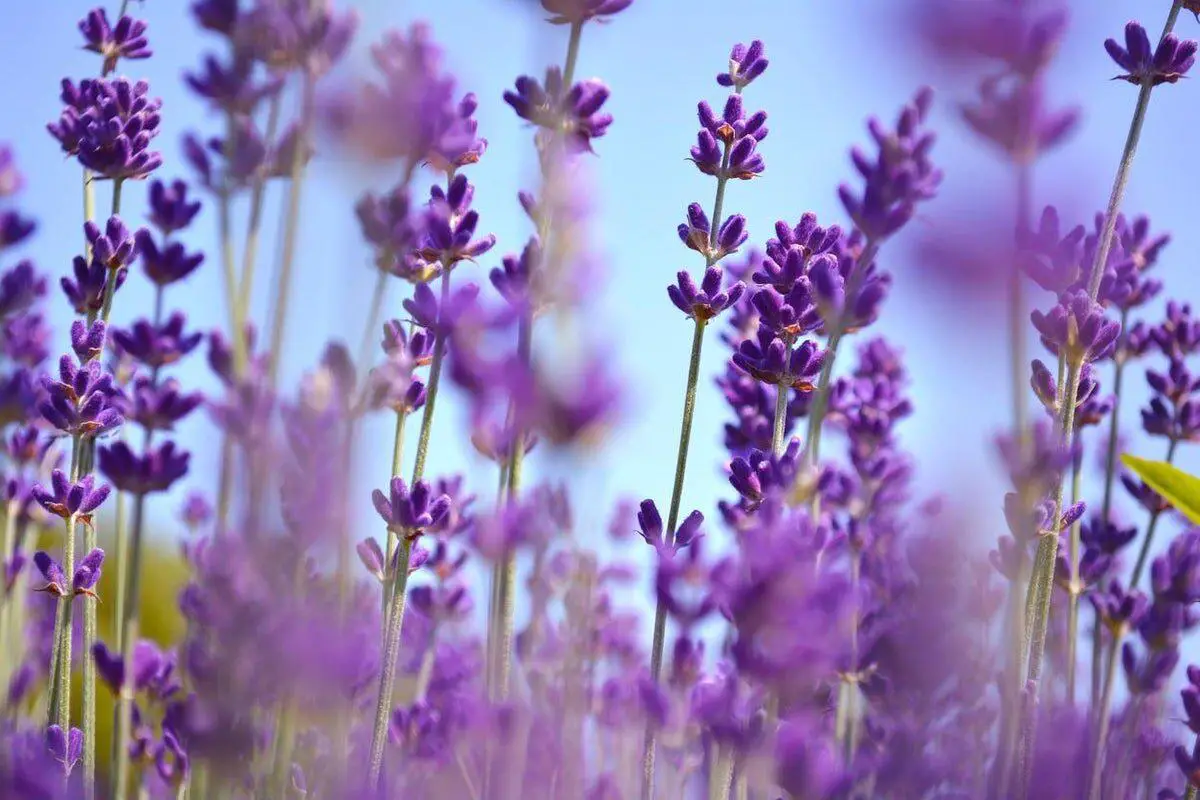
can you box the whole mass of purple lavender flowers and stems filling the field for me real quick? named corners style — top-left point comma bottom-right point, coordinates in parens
top-left (7, 0), bottom-right (1200, 800)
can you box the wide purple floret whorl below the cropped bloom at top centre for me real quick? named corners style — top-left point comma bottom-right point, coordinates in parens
top-left (504, 67), bottom-right (612, 152)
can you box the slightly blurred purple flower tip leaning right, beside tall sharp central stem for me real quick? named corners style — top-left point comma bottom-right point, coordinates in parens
top-left (838, 89), bottom-right (942, 243)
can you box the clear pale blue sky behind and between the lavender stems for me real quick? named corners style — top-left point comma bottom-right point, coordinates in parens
top-left (7, 0), bottom-right (1200, 582)
